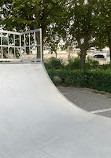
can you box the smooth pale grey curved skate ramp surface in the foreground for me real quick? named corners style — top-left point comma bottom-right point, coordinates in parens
top-left (0, 63), bottom-right (111, 158)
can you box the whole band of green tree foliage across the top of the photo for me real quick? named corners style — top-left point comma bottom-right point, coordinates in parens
top-left (0, 0), bottom-right (111, 68)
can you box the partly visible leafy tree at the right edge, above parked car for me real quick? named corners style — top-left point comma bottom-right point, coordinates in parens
top-left (95, 0), bottom-right (111, 68)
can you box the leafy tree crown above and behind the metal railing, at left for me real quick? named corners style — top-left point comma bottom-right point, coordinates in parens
top-left (2, 0), bottom-right (65, 57)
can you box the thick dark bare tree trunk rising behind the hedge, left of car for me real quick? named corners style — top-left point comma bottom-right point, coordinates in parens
top-left (80, 49), bottom-right (87, 70)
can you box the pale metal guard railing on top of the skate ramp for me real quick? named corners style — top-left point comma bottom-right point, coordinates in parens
top-left (0, 28), bottom-right (42, 62)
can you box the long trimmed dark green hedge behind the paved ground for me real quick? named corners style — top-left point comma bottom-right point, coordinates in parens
top-left (48, 70), bottom-right (111, 93)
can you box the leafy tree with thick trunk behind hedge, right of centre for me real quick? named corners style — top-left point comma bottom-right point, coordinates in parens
top-left (65, 0), bottom-right (97, 69)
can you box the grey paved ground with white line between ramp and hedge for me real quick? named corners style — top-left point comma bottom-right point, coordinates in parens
top-left (58, 87), bottom-right (111, 117)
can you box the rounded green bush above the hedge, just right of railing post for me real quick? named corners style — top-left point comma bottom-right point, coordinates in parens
top-left (45, 57), bottom-right (64, 70)
